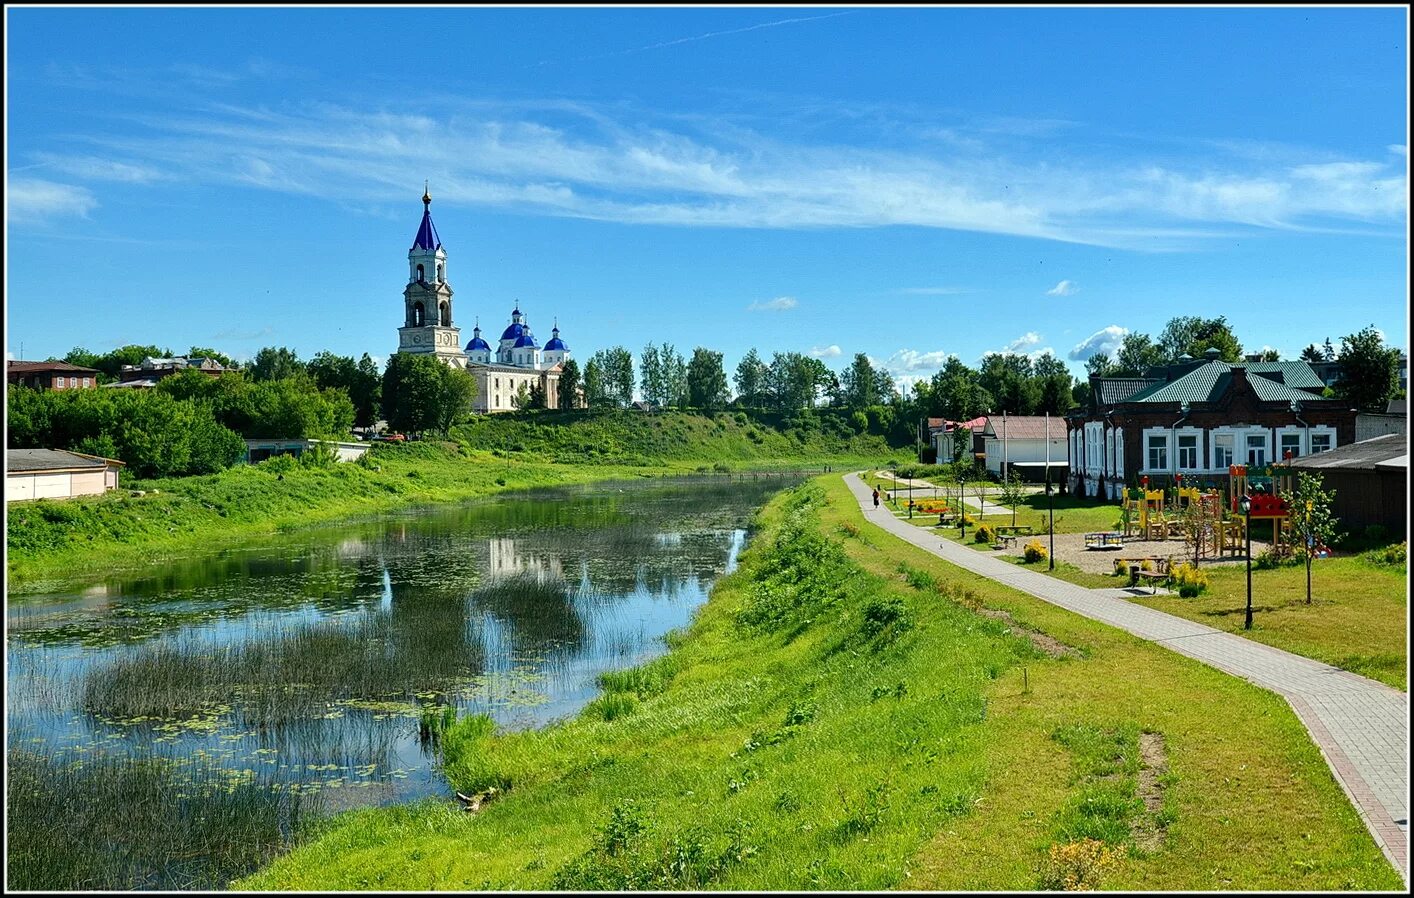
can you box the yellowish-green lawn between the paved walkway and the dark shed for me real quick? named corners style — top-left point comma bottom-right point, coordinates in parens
top-left (1135, 556), bottom-right (1408, 690)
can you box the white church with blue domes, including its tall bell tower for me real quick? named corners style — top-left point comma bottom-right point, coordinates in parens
top-left (397, 189), bottom-right (578, 413)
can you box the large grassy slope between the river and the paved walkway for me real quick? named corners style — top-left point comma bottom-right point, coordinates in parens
top-left (236, 477), bottom-right (1400, 890)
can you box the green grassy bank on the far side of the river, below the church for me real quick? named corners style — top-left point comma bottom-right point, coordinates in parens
top-left (6, 412), bottom-right (888, 594)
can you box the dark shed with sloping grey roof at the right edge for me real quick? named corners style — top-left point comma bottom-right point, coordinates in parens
top-left (1291, 433), bottom-right (1410, 533)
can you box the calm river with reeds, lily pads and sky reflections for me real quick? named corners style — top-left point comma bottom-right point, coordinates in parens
top-left (6, 477), bottom-right (786, 888)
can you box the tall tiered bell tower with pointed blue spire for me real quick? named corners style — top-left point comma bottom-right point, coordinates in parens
top-left (397, 185), bottom-right (467, 368)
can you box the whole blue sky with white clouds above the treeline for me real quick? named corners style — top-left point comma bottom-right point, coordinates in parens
top-left (6, 7), bottom-right (1408, 390)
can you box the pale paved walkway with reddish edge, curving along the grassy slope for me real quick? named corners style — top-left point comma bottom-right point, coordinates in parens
top-left (844, 474), bottom-right (1410, 884)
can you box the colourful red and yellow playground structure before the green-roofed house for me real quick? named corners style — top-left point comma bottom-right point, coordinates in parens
top-left (1120, 462), bottom-right (1329, 561)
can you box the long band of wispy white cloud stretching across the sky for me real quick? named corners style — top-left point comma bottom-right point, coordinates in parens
top-left (24, 91), bottom-right (1408, 248)
